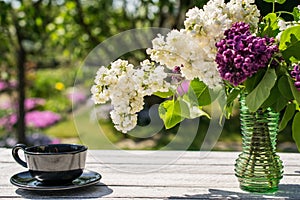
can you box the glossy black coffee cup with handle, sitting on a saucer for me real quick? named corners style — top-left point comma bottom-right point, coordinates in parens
top-left (12, 144), bottom-right (87, 184)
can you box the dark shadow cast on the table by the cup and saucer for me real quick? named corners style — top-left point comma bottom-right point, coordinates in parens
top-left (16, 183), bottom-right (113, 199)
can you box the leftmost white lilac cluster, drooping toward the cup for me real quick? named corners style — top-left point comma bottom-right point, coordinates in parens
top-left (91, 59), bottom-right (171, 133)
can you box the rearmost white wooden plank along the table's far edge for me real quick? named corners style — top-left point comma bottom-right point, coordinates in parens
top-left (0, 148), bottom-right (300, 166)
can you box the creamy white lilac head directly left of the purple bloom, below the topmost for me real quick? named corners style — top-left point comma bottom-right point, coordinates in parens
top-left (147, 29), bottom-right (220, 88)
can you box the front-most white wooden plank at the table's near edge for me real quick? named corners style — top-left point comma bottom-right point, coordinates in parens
top-left (0, 184), bottom-right (300, 199)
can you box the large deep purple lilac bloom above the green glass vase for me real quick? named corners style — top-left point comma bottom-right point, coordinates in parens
top-left (216, 22), bottom-right (278, 86)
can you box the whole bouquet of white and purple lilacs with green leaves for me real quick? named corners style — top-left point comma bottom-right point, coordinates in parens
top-left (91, 0), bottom-right (300, 149)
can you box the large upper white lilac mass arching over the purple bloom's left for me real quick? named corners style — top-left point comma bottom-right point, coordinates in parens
top-left (147, 0), bottom-right (259, 88)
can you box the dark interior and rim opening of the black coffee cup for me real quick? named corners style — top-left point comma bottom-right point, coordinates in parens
top-left (26, 144), bottom-right (86, 154)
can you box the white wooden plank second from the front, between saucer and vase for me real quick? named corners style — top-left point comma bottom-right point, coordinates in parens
top-left (4, 167), bottom-right (300, 188)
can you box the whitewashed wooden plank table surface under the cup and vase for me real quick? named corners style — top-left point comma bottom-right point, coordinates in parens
top-left (0, 148), bottom-right (300, 199)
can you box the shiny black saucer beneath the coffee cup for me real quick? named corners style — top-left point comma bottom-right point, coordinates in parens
top-left (10, 170), bottom-right (101, 190)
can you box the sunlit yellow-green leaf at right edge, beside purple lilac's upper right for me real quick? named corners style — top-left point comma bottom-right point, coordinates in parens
top-left (279, 25), bottom-right (300, 60)
